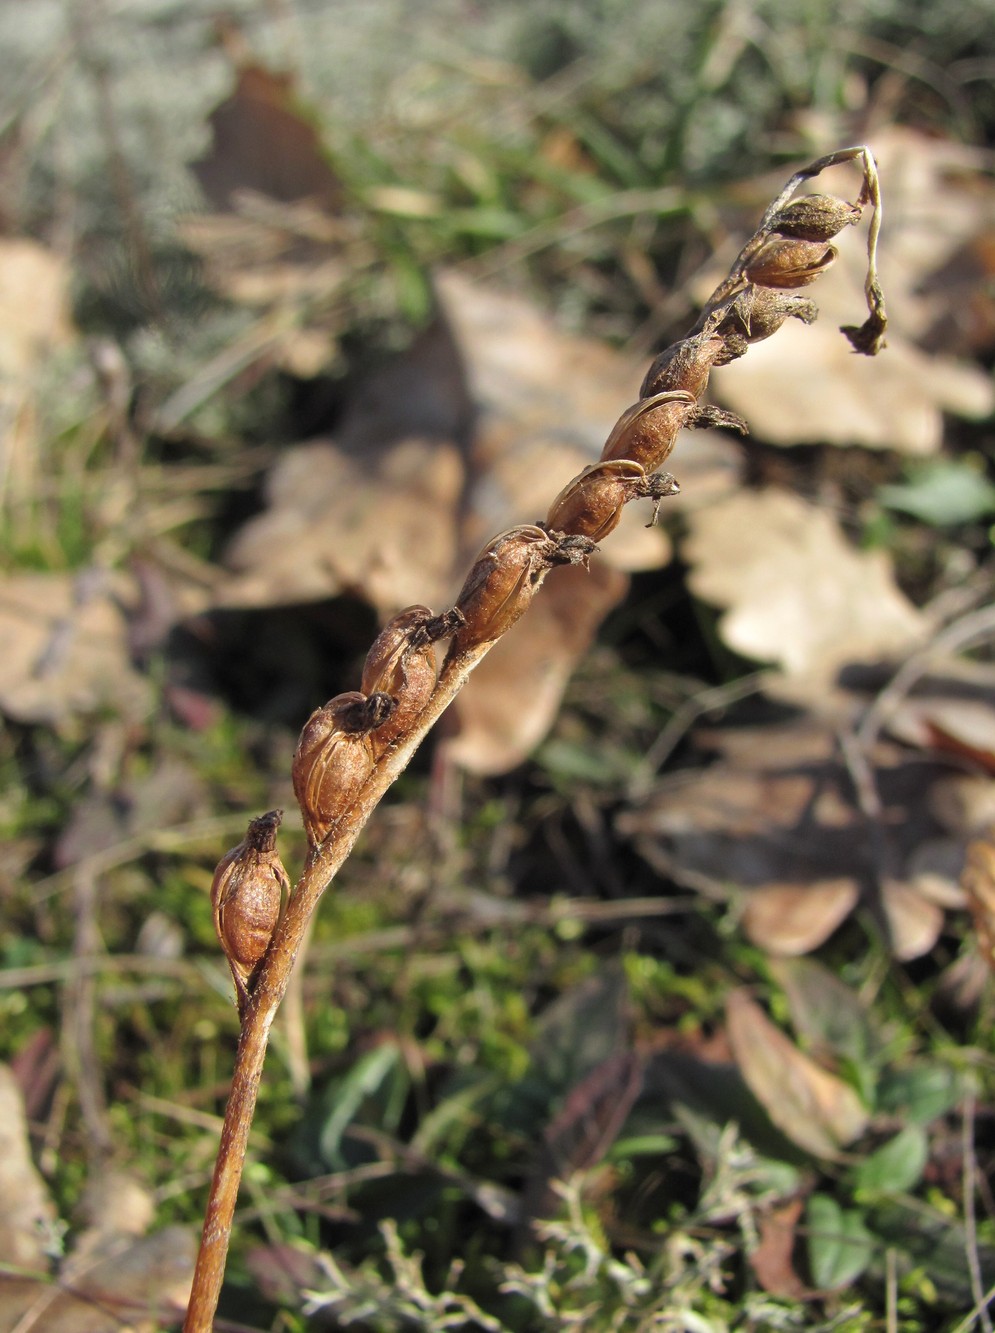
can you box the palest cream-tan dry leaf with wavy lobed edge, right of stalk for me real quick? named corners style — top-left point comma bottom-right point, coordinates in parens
top-left (683, 489), bottom-right (926, 706)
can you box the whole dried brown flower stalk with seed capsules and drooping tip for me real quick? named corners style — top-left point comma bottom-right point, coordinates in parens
top-left (184, 147), bottom-right (887, 1333)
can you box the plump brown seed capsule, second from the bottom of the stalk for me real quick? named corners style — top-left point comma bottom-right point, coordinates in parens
top-left (292, 689), bottom-right (381, 846)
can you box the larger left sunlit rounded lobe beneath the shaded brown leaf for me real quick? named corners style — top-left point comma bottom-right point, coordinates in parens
top-left (743, 877), bottom-right (860, 957)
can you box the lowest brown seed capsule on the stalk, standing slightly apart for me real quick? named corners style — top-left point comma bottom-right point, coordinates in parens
top-left (211, 810), bottom-right (291, 1013)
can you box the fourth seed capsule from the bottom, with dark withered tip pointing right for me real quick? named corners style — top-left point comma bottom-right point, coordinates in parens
top-left (453, 524), bottom-right (595, 651)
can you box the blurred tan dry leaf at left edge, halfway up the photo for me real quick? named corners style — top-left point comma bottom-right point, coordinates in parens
top-left (0, 571), bottom-right (148, 724)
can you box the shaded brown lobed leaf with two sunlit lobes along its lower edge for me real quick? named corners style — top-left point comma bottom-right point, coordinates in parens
top-left (618, 717), bottom-right (963, 957)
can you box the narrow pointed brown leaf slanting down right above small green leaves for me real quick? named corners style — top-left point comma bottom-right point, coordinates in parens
top-left (726, 990), bottom-right (868, 1158)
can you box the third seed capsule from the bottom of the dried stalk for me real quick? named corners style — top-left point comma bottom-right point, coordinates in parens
top-left (361, 607), bottom-right (463, 757)
